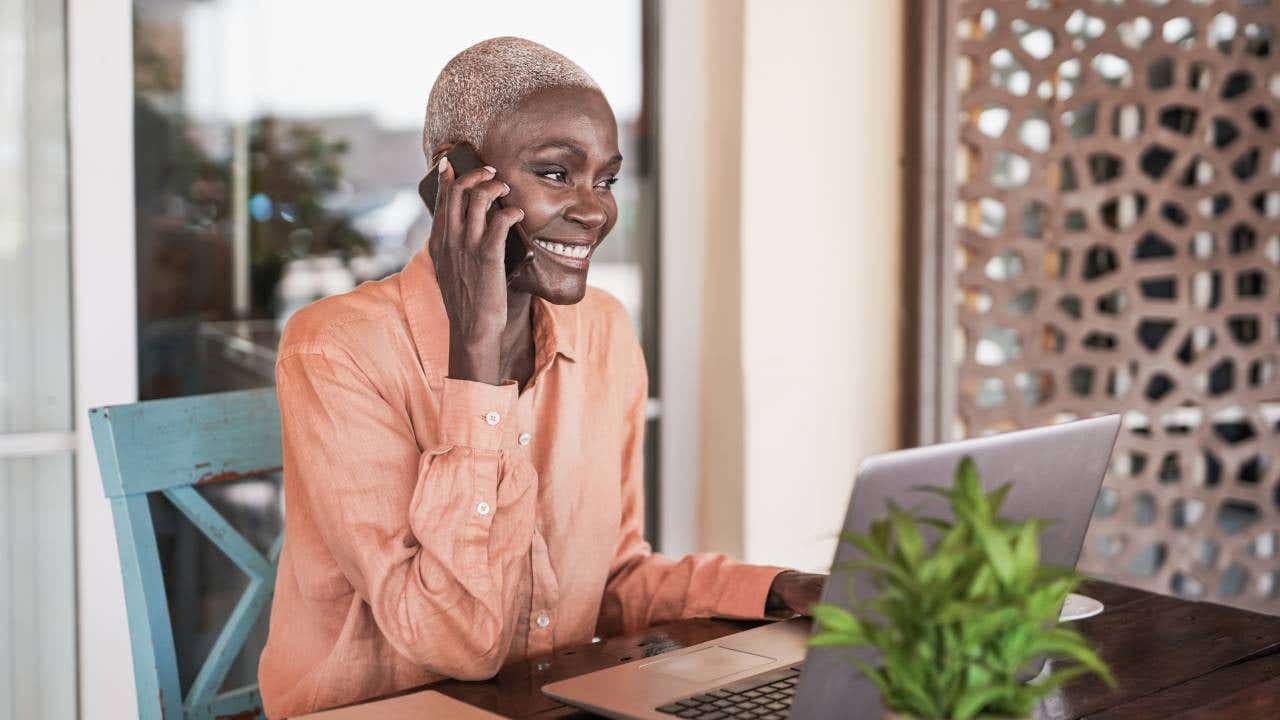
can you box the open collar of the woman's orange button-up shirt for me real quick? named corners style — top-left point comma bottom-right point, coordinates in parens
top-left (401, 247), bottom-right (580, 387)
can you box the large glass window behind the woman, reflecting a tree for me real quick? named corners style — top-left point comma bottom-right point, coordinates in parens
top-left (127, 0), bottom-right (662, 696)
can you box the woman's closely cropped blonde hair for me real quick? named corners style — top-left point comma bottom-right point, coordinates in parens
top-left (422, 37), bottom-right (599, 161)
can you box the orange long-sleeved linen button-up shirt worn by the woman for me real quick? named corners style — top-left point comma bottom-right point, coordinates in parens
top-left (259, 245), bottom-right (780, 717)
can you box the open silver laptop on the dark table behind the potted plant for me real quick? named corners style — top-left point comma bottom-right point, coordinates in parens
top-left (543, 415), bottom-right (1120, 720)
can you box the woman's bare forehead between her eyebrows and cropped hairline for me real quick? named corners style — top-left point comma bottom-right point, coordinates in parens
top-left (484, 87), bottom-right (618, 159)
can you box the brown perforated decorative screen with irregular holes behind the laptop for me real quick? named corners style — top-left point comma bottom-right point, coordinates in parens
top-left (938, 0), bottom-right (1280, 612)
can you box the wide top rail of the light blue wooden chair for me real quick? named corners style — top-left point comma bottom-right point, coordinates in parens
top-left (90, 388), bottom-right (282, 497)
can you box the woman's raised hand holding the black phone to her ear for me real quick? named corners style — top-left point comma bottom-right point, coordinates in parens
top-left (428, 158), bottom-right (525, 384)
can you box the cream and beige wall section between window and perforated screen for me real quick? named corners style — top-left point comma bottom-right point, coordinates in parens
top-left (698, 0), bottom-right (902, 569)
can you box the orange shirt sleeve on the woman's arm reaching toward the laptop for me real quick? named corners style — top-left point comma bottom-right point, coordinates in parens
top-left (596, 325), bottom-right (783, 635)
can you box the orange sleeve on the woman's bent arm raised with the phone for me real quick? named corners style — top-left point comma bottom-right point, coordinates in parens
top-left (276, 350), bottom-right (535, 679)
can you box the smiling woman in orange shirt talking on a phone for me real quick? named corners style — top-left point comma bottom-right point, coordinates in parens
top-left (259, 37), bottom-right (822, 716)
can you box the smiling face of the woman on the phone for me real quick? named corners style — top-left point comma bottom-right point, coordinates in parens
top-left (480, 87), bottom-right (622, 305)
